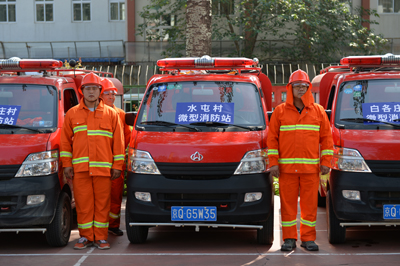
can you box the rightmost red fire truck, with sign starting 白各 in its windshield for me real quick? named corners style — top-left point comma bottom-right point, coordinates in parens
top-left (312, 54), bottom-right (400, 244)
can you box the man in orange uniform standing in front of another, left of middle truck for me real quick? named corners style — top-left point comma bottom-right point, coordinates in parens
top-left (60, 73), bottom-right (124, 249)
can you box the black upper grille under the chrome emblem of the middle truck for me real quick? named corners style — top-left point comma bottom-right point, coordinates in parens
top-left (156, 163), bottom-right (239, 180)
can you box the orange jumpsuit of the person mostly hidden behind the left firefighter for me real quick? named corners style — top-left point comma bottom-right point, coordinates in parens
top-left (109, 105), bottom-right (132, 228)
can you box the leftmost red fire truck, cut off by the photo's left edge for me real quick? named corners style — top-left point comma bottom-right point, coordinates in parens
top-left (0, 58), bottom-right (122, 246)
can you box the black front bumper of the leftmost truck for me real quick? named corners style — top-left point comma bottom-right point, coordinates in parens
top-left (0, 173), bottom-right (61, 228)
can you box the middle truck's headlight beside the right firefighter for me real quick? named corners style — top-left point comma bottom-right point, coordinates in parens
top-left (234, 149), bottom-right (268, 175)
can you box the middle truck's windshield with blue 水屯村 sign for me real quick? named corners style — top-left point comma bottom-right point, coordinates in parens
top-left (138, 81), bottom-right (265, 131)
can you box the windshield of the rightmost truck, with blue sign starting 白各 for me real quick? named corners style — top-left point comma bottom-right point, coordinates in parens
top-left (335, 79), bottom-right (400, 129)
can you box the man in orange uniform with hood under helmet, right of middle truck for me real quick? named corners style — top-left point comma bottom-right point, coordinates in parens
top-left (267, 70), bottom-right (333, 251)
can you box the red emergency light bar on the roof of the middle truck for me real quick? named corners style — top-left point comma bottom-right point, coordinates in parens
top-left (157, 56), bottom-right (258, 69)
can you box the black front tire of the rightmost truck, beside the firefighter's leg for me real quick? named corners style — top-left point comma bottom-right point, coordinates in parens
top-left (326, 191), bottom-right (346, 244)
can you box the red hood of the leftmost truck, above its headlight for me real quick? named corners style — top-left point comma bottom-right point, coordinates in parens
top-left (0, 134), bottom-right (50, 165)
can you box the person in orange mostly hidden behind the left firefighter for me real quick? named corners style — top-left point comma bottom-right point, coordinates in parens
top-left (100, 78), bottom-right (132, 236)
